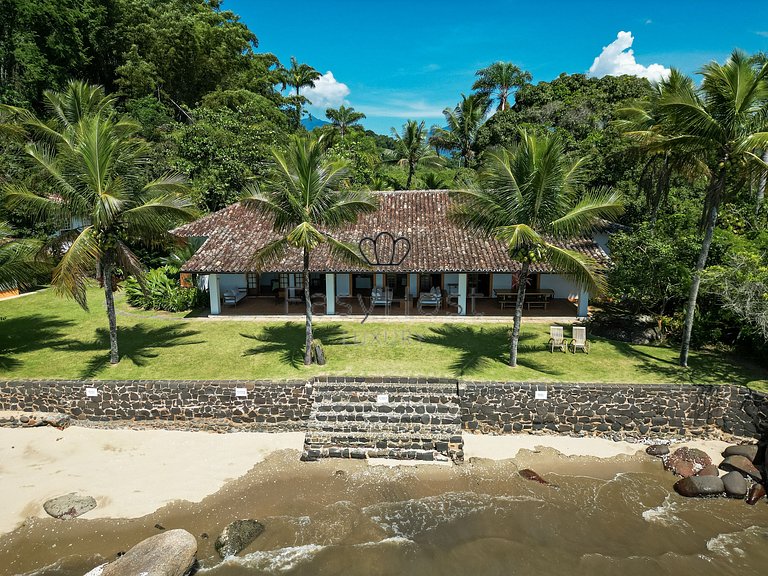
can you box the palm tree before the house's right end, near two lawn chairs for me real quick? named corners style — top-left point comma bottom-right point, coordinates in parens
top-left (451, 131), bottom-right (622, 367)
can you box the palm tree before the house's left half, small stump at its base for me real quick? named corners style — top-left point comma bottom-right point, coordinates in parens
top-left (243, 136), bottom-right (377, 365)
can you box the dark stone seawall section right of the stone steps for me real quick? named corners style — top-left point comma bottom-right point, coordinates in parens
top-left (459, 382), bottom-right (768, 437)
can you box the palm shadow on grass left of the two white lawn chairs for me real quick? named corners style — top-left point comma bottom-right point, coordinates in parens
top-left (413, 324), bottom-right (559, 376)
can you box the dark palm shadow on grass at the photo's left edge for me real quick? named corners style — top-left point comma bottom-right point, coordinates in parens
top-left (0, 314), bottom-right (77, 372)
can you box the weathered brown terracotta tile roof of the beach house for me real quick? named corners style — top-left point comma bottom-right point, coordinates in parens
top-left (173, 190), bottom-right (608, 273)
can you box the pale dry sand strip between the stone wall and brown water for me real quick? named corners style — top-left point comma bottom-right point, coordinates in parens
top-left (0, 426), bottom-right (727, 533)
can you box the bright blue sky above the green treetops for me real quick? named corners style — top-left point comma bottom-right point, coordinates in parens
top-left (223, 0), bottom-right (768, 134)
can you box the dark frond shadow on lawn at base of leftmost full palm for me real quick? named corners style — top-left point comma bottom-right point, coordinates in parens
top-left (70, 323), bottom-right (202, 378)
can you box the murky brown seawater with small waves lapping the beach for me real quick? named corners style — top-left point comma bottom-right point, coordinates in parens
top-left (0, 453), bottom-right (768, 576)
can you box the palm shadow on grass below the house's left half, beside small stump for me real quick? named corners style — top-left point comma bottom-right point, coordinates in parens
top-left (240, 322), bottom-right (355, 368)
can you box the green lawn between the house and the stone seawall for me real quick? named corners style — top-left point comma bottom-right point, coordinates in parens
top-left (0, 288), bottom-right (768, 390)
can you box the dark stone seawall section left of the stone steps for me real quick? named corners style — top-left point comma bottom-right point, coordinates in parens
top-left (0, 380), bottom-right (312, 425)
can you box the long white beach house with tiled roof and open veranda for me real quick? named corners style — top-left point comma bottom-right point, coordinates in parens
top-left (174, 190), bottom-right (608, 317)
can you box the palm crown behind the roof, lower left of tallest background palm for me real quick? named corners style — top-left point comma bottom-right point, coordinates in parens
top-left (433, 93), bottom-right (491, 166)
